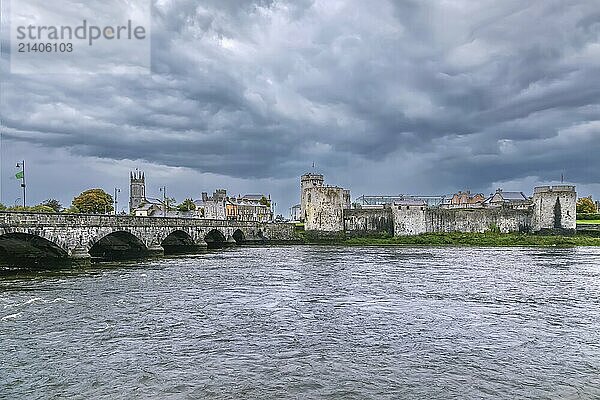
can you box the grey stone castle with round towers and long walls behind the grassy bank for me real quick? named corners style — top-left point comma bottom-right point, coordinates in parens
top-left (300, 173), bottom-right (577, 236)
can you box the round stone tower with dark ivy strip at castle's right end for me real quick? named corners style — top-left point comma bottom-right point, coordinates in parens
top-left (532, 185), bottom-right (577, 232)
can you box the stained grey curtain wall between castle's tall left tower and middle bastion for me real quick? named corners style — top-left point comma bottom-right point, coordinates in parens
top-left (344, 208), bottom-right (394, 235)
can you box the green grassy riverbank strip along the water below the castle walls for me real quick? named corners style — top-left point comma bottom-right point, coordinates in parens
top-left (304, 232), bottom-right (600, 247)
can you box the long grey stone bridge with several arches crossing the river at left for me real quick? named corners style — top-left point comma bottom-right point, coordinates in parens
top-left (0, 212), bottom-right (295, 259)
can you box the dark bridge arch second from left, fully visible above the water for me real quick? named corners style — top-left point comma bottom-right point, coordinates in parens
top-left (88, 230), bottom-right (148, 259)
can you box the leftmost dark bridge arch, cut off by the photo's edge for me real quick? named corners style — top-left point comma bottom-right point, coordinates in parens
top-left (0, 232), bottom-right (68, 260)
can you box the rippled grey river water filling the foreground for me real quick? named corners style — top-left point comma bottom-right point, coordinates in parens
top-left (0, 246), bottom-right (600, 400)
